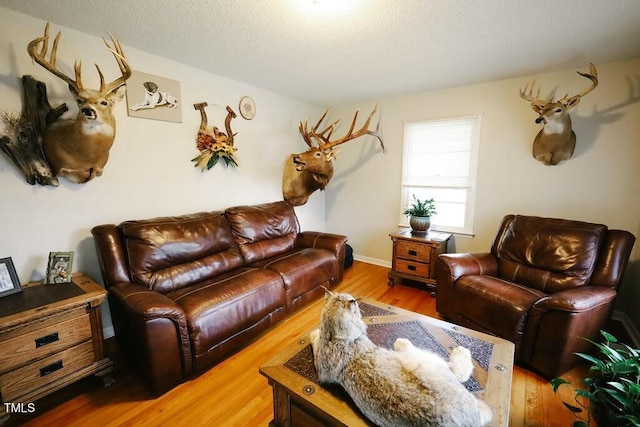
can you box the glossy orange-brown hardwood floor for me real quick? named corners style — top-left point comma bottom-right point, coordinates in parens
top-left (5, 261), bottom-right (586, 427)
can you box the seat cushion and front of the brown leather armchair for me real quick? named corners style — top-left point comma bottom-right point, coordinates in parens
top-left (454, 275), bottom-right (546, 348)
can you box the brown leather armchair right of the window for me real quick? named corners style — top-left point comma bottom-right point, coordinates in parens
top-left (436, 215), bottom-right (635, 379)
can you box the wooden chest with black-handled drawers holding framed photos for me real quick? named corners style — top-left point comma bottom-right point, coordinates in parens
top-left (0, 273), bottom-right (113, 423)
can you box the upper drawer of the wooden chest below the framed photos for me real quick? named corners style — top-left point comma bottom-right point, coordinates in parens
top-left (0, 314), bottom-right (91, 372)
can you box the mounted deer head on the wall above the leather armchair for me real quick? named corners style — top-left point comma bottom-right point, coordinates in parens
top-left (520, 64), bottom-right (598, 165)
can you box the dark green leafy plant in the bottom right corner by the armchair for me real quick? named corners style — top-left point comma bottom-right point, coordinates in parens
top-left (551, 331), bottom-right (640, 427)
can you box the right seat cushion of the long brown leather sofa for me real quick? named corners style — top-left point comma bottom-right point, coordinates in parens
top-left (252, 248), bottom-right (338, 299)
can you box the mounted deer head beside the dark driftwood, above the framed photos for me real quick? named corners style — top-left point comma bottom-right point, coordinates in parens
top-left (27, 23), bottom-right (131, 183)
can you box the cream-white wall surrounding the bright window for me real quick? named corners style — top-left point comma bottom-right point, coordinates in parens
top-left (326, 59), bottom-right (640, 329)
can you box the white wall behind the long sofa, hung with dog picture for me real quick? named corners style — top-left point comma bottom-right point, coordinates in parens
top-left (0, 8), bottom-right (325, 338)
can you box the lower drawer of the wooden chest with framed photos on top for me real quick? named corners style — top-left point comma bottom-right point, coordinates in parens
top-left (0, 341), bottom-right (95, 402)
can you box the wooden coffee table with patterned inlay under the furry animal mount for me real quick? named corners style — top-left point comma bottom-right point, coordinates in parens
top-left (260, 299), bottom-right (514, 427)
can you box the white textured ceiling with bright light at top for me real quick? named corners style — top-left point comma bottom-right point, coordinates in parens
top-left (0, 0), bottom-right (640, 106)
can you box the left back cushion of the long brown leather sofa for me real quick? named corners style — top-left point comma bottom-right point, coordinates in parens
top-left (118, 212), bottom-right (243, 293)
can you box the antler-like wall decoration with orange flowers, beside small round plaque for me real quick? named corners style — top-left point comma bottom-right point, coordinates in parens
top-left (191, 102), bottom-right (238, 172)
